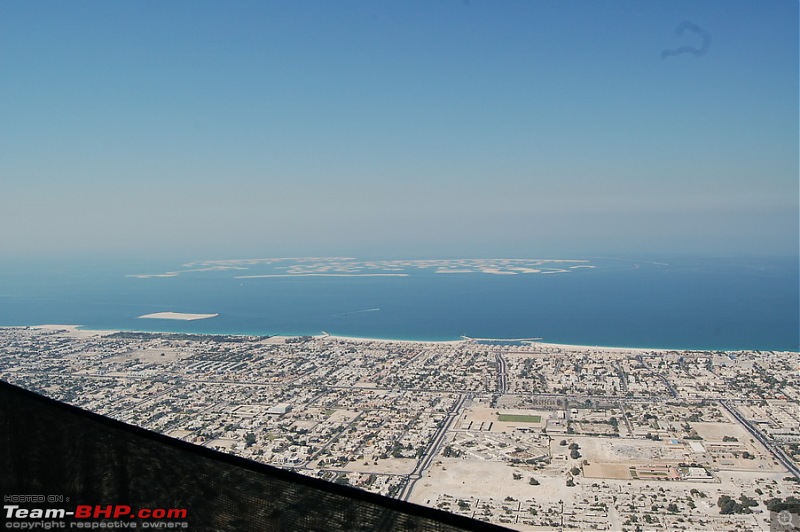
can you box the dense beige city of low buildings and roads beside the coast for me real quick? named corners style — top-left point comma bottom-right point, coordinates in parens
top-left (0, 326), bottom-right (800, 532)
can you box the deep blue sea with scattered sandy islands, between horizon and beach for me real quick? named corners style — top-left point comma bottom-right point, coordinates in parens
top-left (0, 255), bottom-right (800, 351)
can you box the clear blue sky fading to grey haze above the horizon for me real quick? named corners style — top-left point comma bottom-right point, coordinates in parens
top-left (0, 0), bottom-right (800, 260)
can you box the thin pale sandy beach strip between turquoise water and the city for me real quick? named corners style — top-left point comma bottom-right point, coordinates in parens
top-left (26, 324), bottom-right (800, 354)
